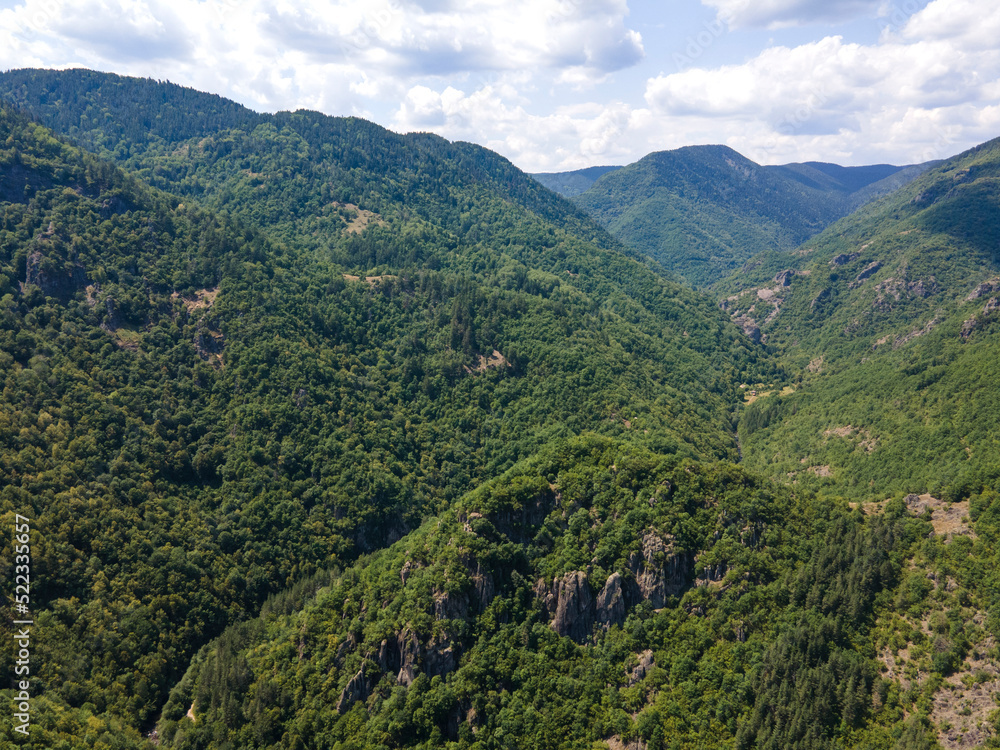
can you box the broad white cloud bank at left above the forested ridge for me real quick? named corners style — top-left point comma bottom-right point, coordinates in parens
top-left (0, 0), bottom-right (644, 125)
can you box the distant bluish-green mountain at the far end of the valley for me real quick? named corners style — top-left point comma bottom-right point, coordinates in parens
top-left (573, 146), bottom-right (936, 286)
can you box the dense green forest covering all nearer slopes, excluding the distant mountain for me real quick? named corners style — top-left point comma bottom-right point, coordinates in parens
top-left (0, 70), bottom-right (1000, 750)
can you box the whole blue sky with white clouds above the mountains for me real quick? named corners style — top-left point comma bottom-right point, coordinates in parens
top-left (0, 0), bottom-right (1000, 172)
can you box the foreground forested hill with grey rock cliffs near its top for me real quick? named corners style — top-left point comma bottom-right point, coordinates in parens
top-left (159, 438), bottom-right (968, 750)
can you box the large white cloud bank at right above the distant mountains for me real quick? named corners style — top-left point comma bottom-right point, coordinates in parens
top-left (646, 0), bottom-right (1000, 163)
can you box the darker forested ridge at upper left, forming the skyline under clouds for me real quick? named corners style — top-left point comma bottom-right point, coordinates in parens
top-left (0, 70), bottom-right (624, 271)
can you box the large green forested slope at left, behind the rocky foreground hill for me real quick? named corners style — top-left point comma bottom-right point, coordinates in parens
top-left (0, 83), bottom-right (773, 747)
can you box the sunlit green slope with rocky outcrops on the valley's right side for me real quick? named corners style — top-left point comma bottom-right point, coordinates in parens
top-left (720, 141), bottom-right (1000, 506)
